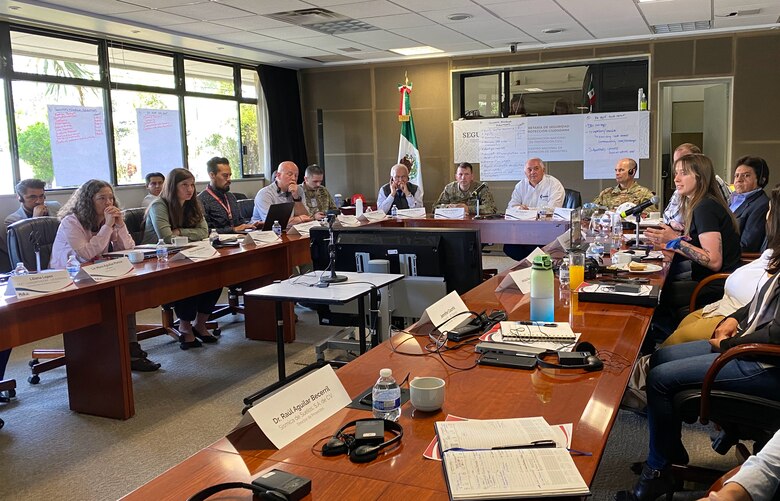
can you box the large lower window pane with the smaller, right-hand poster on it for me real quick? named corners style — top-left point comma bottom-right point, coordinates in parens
top-left (111, 90), bottom-right (184, 185)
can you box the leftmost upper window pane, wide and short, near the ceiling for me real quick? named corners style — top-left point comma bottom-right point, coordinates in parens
top-left (11, 31), bottom-right (100, 80)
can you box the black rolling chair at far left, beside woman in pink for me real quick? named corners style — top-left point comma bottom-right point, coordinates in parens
top-left (8, 216), bottom-right (65, 384)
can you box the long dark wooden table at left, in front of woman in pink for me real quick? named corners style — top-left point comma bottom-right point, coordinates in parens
top-left (0, 236), bottom-right (310, 419)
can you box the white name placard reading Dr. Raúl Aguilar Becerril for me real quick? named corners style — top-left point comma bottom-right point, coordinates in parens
top-left (249, 365), bottom-right (351, 449)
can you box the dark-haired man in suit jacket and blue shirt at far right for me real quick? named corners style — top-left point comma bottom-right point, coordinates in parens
top-left (729, 156), bottom-right (769, 252)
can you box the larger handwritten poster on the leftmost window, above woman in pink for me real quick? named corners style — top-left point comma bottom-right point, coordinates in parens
top-left (48, 104), bottom-right (110, 187)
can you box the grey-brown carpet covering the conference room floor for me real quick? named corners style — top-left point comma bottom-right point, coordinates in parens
top-left (0, 253), bottom-right (736, 500)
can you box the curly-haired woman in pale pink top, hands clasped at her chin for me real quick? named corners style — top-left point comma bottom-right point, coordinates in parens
top-left (49, 179), bottom-right (160, 372)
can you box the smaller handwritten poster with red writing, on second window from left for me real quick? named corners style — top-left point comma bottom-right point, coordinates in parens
top-left (135, 108), bottom-right (184, 176)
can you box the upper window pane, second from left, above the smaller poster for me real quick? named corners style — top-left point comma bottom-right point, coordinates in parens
top-left (108, 46), bottom-right (176, 89)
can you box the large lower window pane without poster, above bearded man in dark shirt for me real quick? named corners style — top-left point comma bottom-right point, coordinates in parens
top-left (184, 97), bottom-right (241, 181)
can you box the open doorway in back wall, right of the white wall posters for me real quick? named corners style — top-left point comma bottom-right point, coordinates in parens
top-left (656, 78), bottom-right (734, 206)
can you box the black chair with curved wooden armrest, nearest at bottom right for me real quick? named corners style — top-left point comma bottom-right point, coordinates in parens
top-left (673, 343), bottom-right (780, 482)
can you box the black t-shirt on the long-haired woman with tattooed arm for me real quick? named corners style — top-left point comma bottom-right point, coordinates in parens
top-left (689, 197), bottom-right (742, 281)
